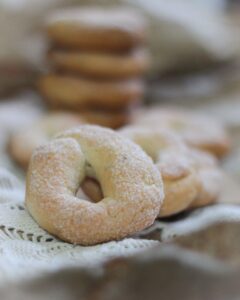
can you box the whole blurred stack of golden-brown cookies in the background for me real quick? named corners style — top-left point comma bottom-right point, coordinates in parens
top-left (39, 8), bottom-right (149, 128)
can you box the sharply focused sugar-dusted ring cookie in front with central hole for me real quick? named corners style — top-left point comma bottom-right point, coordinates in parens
top-left (26, 125), bottom-right (163, 245)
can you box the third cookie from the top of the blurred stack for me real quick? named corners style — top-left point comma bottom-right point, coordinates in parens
top-left (38, 74), bottom-right (144, 110)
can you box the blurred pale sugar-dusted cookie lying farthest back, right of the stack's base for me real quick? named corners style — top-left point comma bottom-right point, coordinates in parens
top-left (135, 107), bottom-right (230, 157)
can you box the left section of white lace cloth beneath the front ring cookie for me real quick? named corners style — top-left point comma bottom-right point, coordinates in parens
top-left (0, 169), bottom-right (159, 284)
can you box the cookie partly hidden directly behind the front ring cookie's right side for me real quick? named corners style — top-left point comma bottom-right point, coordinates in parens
top-left (120, 125), bottom-right (200, 217)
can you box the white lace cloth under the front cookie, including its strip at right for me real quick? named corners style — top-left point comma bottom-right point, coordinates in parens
top-left (0, 158), bottom-right (240, 285)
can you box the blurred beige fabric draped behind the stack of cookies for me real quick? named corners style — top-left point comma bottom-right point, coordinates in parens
top-left (0, 0), bottom-right (240, 94)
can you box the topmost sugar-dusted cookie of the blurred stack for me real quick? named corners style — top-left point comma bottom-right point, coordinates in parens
top-left (47, 8), bottom-right (146, 51)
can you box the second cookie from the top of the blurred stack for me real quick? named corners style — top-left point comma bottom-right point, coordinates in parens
top-left (48, 49), bottom-right (150, 79)
